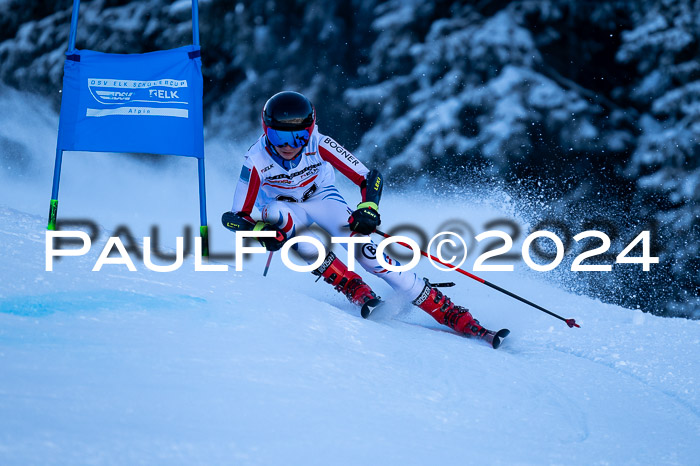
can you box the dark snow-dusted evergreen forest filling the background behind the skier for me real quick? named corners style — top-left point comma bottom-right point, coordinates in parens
top-left (0, 0), bottom-right (700, 318)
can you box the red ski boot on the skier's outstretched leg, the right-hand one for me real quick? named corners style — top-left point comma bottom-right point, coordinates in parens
top-left (413, 278), bottom-right (507, 348)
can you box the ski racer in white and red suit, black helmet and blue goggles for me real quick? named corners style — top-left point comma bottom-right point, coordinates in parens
top-left (222, 91), bottom-right (505, 347)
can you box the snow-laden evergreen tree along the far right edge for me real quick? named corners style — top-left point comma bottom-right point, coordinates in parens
top-left (617, 0), bottom-right (700, 318)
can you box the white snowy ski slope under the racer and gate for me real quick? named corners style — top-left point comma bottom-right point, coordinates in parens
top-left (0, 88), bottom-right (700, 465)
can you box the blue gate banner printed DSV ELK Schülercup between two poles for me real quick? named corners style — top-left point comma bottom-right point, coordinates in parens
top-left (58, 45), bottom-right (204, 158)
